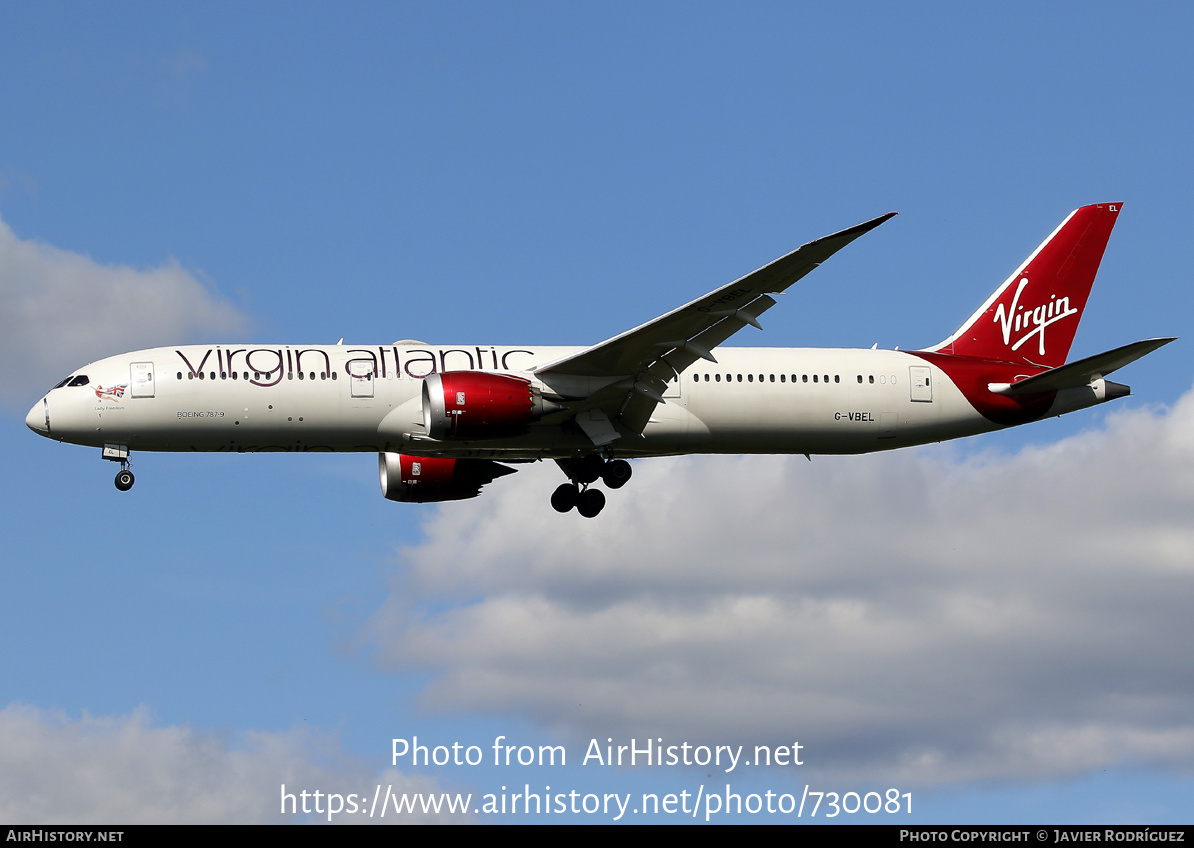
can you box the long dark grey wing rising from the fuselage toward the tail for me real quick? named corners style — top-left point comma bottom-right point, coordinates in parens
top-left (535, 213), bottom-right (896, 445)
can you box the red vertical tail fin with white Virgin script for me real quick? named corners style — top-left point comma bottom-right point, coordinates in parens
top-left (929, 203), bottom-right (1122, 368)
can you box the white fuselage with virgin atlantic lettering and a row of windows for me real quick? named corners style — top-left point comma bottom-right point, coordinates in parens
top-left (26, 344), bottom-right (1109, 459)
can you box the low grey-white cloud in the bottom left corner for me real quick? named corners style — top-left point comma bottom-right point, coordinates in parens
top-left (0, 703), bottom-right (460, 824)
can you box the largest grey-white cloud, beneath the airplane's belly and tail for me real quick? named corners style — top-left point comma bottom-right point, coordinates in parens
top-left (374, 393), bottom-right (1194, 785)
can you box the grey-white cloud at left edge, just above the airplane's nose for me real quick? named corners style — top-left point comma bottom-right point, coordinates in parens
top-left (0, 221), bottom-right (248, 408)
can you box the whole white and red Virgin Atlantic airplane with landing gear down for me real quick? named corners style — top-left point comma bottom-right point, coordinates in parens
top-left (25, 203), bottom-right (1174, 518)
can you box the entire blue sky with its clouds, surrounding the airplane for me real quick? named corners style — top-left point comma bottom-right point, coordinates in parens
top-left (0, 2), bottom-right (1194, 823)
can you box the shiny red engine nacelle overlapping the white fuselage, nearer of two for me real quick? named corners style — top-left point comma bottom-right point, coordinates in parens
top-left (423, 371), bottom-right (542, 441)
